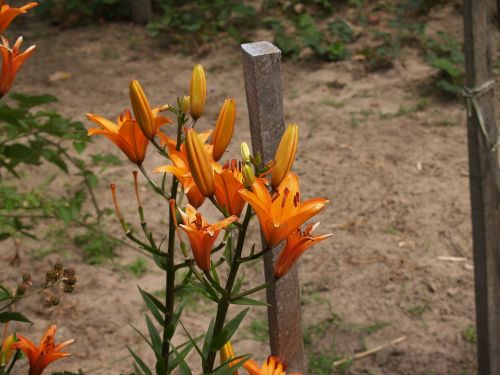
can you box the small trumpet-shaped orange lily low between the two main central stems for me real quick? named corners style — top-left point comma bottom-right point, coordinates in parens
top-left (179, 204), bottom-right (238, 271)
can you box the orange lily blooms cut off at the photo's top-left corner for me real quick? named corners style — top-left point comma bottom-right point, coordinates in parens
top-left (0, 0), bottom-right (38, 98)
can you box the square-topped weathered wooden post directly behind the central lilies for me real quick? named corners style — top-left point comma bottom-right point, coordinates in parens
top-left (241, 42), bottom-right (305, 373)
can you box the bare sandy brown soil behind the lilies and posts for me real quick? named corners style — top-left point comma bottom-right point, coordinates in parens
top-left (0, 2), bottom-right (494, 375)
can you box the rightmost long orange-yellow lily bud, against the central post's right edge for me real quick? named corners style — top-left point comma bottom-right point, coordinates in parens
top-left (271, 124), bottom-right (299, 188)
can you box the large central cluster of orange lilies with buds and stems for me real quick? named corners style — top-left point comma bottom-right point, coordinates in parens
top-left (87, 65), bottom-right (331, 375)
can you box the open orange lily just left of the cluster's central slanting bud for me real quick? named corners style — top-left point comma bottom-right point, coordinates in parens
top-left (153, 148), bottom-right (205, 208)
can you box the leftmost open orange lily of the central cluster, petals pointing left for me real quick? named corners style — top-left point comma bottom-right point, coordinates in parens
top-left (87, 110), bottom-right (149, 165)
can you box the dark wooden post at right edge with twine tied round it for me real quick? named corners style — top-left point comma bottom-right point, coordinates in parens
top-left (463, 0), bottom-right (500, 375)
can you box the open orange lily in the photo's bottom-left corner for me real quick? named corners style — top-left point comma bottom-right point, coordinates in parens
top-left (12, 324), bottom-right (75, 375)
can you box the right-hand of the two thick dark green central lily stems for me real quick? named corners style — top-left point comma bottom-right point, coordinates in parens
top-left (204, 206), bottom-right (252, 374)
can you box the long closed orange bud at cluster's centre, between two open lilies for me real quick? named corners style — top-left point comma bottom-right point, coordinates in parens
top-left (186, 129), bottom-right (215, 197)
